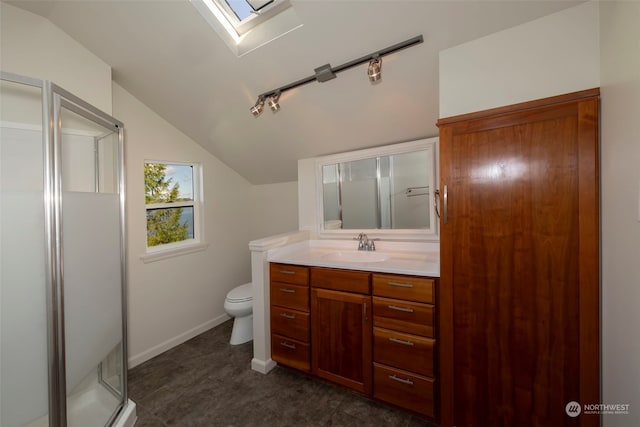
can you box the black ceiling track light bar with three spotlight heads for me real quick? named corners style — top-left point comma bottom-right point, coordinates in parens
top-left (251, 35), bottom-right (424, 117)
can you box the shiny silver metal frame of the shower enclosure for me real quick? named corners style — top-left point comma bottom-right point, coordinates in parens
top-left (0, 71), bottom-right (128, 427)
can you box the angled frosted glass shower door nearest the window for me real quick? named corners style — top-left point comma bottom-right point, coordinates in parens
top-left (53, 87), bottom-right (126, 427)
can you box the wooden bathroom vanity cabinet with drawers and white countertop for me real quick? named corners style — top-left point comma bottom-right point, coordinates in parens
top-left (269, 241), bottom-right (439, 419)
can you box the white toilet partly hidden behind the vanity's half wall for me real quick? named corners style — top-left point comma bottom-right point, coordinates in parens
top-left (224, 283), bottom-right (253, 345)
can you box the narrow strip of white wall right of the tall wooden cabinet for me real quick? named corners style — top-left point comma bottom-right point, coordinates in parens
top-left (600, 1), bottom-right (640, 427)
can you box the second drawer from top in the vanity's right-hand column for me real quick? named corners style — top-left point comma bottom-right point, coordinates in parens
top-left (373, 297), bottom-right (435, 338)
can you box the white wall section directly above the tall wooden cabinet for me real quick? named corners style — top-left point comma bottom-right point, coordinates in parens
top-left (440, 2), bottom-right (600, 117)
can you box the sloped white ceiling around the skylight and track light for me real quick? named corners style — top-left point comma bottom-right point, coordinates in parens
top-left (8, 0), bottom-right (579, 184)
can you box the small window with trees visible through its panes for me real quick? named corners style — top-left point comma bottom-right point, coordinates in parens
top-left (144, 161), bottom-right (202, 253)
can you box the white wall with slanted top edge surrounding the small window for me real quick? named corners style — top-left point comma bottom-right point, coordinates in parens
top-left (113, 83), bottom-right (255, 366)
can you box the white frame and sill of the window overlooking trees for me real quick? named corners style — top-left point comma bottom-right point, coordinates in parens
top-left (141, 159), bottom-right (209, 263)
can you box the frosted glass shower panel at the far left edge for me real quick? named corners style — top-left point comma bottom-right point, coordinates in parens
top-left (0, 74), bottom-right (50, 427)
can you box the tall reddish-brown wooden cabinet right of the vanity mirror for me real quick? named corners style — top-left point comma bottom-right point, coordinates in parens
top-left (438, 89), bottom-right (600, 427)
